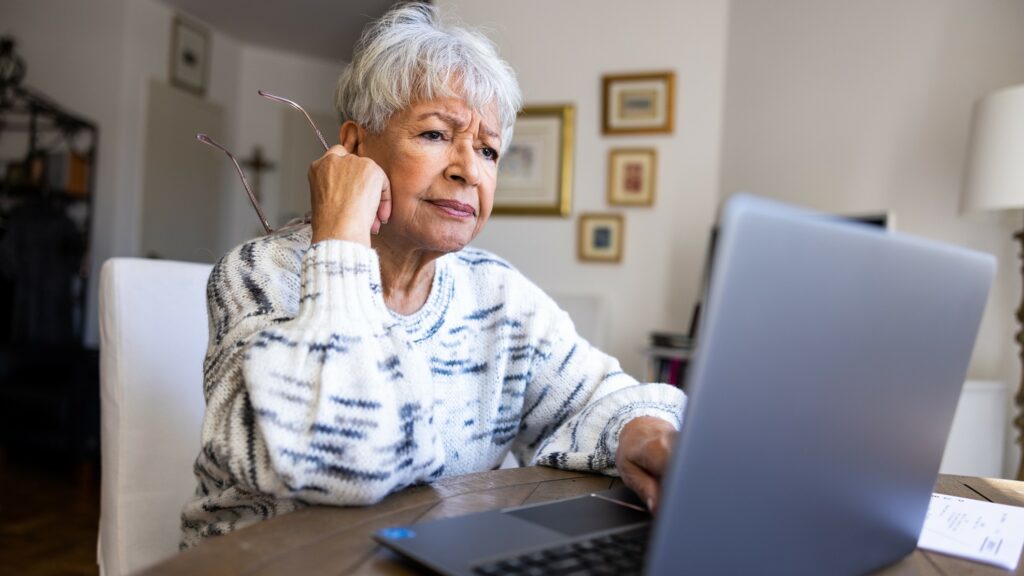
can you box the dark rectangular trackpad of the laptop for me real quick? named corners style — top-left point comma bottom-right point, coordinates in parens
top-left (505, 487), bottom-right (651, 536)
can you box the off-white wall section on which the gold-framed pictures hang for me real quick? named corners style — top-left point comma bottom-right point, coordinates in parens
top-left (436, 0), bottom-right (728, 376)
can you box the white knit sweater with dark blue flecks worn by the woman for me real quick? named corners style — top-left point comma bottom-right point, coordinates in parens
top-left (181, 227), bottom-right (685, 547)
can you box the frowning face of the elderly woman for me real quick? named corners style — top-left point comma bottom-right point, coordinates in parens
top-left (356, 98), bottom-right (502, 253)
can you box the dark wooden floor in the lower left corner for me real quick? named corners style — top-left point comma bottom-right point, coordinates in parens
top-left (0, 448), bottom-right (99, 576)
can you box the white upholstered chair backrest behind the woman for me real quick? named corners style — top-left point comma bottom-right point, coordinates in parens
top-left (98, 258), bottom-right (212, 576)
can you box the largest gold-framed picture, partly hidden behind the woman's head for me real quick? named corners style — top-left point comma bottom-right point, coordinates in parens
top-left (495, 105), bottom-right (574, 216)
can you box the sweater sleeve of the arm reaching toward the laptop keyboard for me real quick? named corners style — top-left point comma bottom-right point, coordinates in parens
top-left (513, 289), bottom-right (686, 476)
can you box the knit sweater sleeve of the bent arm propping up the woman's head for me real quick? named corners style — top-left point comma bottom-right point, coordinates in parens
top-left (198, 235), bottom-right (444, 504)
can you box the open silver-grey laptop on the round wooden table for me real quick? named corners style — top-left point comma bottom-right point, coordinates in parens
top-left (375, 196), bottom-right (995, 575)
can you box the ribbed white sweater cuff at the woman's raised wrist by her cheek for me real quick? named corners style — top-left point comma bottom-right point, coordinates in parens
top-left (298, 240), bottom-right (389, 326)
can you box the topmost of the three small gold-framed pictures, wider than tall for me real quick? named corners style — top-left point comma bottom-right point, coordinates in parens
top-left (602, 72), bottom-right (676, 134)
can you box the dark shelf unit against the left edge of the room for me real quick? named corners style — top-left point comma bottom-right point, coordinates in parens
top-left (0, 36), bottom-right (99, 467)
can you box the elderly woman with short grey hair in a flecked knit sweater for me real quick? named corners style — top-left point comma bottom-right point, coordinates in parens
top-left (182, 5), bottom-right (684, 546)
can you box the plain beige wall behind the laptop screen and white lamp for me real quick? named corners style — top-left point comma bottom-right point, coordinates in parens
top-left (721, 0), bottom-right (1024, 474)
